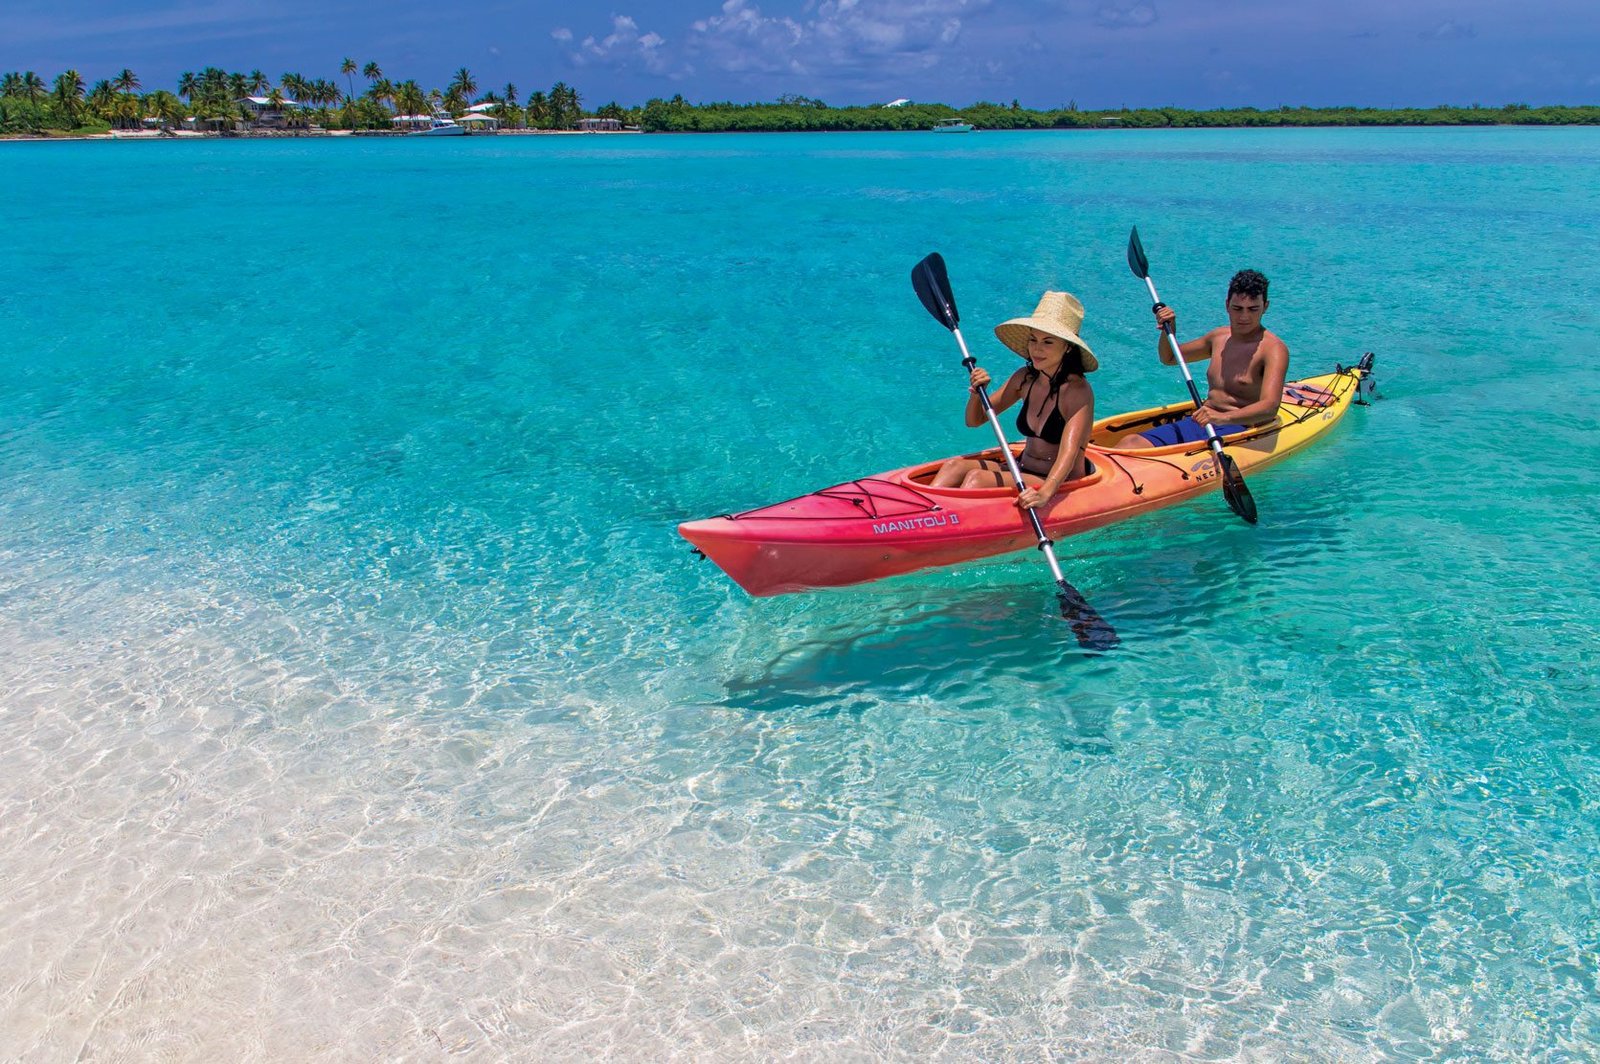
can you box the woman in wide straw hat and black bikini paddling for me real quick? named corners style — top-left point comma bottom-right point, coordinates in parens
top-left (933, 291), bottom-right (1099, 509)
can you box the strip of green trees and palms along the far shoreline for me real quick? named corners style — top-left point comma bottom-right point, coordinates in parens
top-left (0, 59), bottom-right (1600, 134)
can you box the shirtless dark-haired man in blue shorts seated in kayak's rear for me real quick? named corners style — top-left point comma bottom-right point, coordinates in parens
top-left (1117, 270), bottom-right (1290, 448)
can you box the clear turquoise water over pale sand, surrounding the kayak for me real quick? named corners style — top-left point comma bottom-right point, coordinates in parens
top-left (0, 130), bottom-right (1600, 1059)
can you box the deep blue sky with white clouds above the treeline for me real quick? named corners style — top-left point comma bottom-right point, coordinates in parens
top-left (0, 0), bottom-right (1600, 107)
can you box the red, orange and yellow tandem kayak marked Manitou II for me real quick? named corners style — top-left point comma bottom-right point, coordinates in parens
top-left (678, 355), bottom-right (1373, 595)
